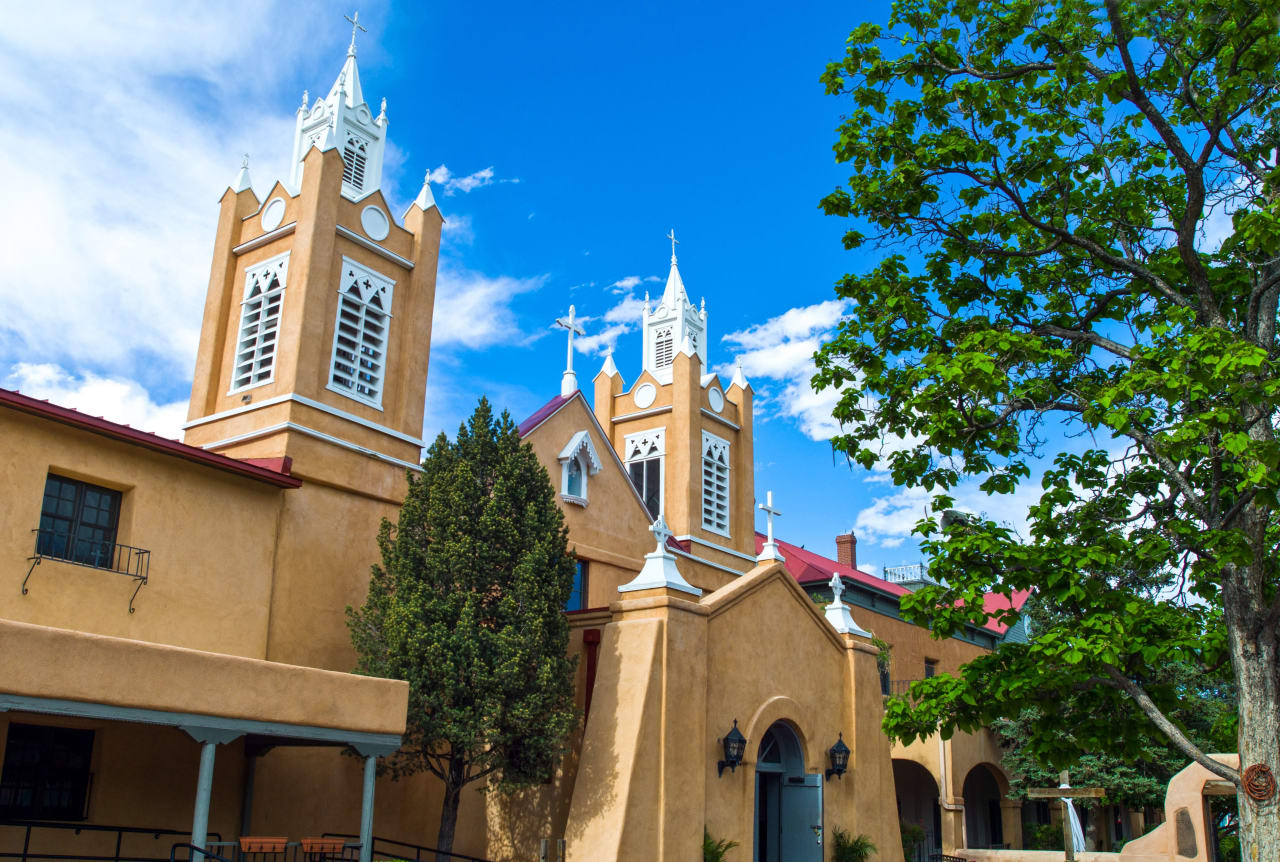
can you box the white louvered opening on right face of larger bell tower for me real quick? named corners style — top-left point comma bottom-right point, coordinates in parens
top-left (329, 260), bottom-right (394, 407)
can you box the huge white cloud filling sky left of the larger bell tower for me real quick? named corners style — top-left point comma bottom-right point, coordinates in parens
top-left (0, 0), bottom-right (378, 377)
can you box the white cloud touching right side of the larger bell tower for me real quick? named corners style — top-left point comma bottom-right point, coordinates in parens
top-left (431, 268), bottom-right (547, 352)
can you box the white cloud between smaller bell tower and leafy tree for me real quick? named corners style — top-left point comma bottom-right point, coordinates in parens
top-left (717, 300), bottom-right (847, 441)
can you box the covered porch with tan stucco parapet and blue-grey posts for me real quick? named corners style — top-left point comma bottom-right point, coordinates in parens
top-left (0, 620), bottom-right (408, 862)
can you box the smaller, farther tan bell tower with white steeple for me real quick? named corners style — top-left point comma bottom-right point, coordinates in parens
top-left (594, 238), bottom-right (755, 571)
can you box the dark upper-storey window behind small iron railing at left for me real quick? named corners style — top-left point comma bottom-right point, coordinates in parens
top-left (36, 473), bottom-right (120, 569)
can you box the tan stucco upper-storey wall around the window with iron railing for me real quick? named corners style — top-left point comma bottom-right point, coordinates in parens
top-left (0, 410), bottom-right (285, 657)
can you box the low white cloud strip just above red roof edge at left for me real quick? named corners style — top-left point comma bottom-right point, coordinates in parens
top-left (4, 362), bottom-right (187, 439)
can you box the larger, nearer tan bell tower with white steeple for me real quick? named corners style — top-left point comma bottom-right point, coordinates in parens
top-left (184, 30), bottom-right (443, 500)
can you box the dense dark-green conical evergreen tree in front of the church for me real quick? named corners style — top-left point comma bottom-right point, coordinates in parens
top-left (347, 398), bottom-right (577, 862)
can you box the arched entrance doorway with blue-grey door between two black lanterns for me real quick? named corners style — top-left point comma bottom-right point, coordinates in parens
top-left (755, 721), bottom-right (822, 862)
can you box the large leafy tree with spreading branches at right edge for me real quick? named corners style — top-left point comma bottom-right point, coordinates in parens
top-left (814, 0), bottom-right (1280, 859)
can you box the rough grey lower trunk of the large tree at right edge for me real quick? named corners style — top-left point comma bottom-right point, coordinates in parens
top-left (1224, 579), bottom-right (1280, 862)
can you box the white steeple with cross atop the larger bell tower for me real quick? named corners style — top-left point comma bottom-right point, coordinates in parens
top-left (289, 14), bottom-right (388, 200)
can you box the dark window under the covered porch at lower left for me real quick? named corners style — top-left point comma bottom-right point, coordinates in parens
top-left (0, 724), bottom-right (93, 820)
